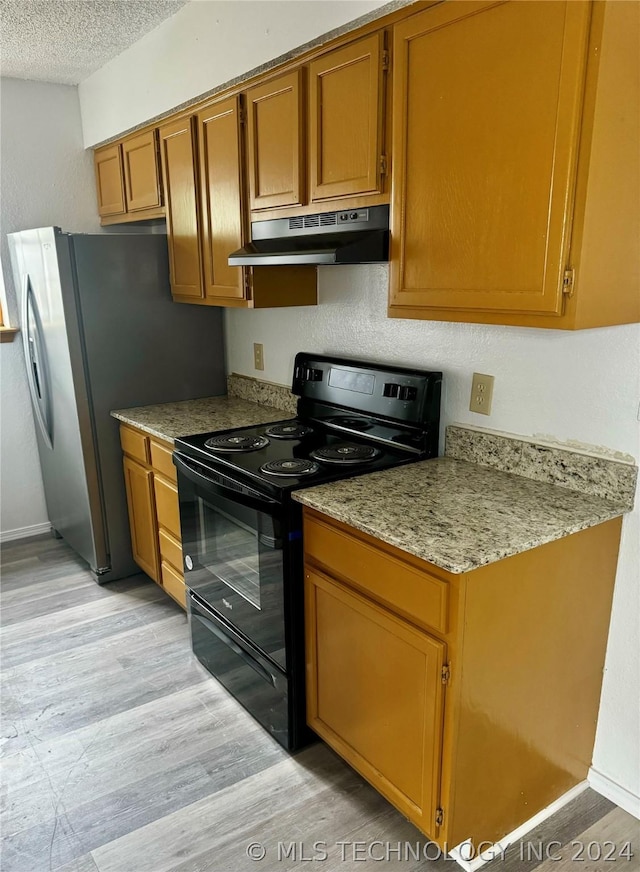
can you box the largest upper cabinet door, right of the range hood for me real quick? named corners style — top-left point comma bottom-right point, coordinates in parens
top-left (391, 0), bottom-right (589, 317)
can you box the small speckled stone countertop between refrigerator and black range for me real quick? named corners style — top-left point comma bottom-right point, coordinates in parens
top-left (111, 396), bottom-right (291, 442)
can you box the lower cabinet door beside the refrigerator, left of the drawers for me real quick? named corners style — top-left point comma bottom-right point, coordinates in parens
top-left (123, 457), bottom-right (160, 582)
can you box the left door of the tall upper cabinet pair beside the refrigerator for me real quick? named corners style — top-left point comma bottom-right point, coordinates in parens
top-left (159, 118), bottom-right (202, 302)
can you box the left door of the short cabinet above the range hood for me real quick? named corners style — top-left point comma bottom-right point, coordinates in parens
top-left (246, 70), bottom-right (305, 209)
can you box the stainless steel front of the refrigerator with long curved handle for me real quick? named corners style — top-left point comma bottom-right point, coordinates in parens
top-left (9, 227), bottom-right (109, 574)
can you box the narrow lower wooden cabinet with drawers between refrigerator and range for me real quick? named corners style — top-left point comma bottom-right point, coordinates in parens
top-left (120, 425), bottom-right (186, 608)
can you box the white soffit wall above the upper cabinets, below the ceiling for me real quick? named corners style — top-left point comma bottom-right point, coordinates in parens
top-left (79, 0), bottom-right (386, 146)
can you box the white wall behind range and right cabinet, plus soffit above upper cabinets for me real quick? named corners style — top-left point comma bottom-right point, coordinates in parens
top-left (80, 0), bottom-right (640, 814)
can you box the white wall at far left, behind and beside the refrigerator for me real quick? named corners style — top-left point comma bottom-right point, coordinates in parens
top-left (0, 79), bottom-right (99, 539)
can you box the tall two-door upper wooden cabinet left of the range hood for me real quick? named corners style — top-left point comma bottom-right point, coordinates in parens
top-left (160, 95), bottom-right (317, 308)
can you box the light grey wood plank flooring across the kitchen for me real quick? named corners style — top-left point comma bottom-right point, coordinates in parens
top-left (0, 537), bottom-right (640, 872)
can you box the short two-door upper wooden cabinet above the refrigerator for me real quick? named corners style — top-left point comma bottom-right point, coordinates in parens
top-left (94, 130), bottom-right (164, 224)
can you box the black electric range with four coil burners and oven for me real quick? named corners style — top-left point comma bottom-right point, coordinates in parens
top-left (174, 352), bottom-right (442, 749)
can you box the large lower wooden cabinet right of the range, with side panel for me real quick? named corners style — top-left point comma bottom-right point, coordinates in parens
top-left (304, 508), bottom-right (621, 850)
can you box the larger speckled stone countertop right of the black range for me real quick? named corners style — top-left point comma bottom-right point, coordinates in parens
top-left (293, 457), bottom-right (627, 573)
